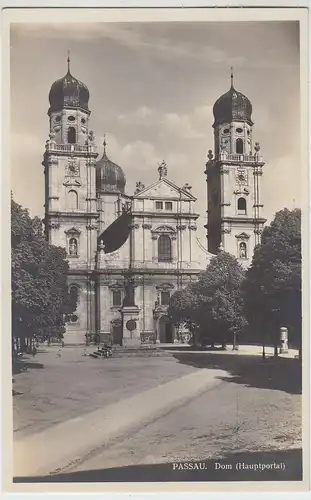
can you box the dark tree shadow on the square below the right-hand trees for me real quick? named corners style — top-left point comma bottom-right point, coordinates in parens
top-left (174, 353), bottom-right (302, 394)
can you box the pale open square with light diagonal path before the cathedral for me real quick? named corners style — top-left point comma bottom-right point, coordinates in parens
top-left (13, 348), bottom-right (301, 476)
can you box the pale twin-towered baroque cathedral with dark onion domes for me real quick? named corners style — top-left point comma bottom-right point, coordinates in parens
top-left (43, 61), bottom-right (264, 346)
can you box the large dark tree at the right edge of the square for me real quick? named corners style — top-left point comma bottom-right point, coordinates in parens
top-left (243, 209), bottom-right (301, 354)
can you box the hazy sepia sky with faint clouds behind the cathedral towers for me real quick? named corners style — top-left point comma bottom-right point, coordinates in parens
top-left (11, 21), bottom-right (301, 246)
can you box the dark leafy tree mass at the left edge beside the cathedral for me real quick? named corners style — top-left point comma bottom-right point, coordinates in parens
top-left (11, 200), bottom-right (75, 349)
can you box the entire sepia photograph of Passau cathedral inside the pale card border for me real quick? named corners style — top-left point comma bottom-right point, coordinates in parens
top-left (2, 9), bottom-right (309, 489)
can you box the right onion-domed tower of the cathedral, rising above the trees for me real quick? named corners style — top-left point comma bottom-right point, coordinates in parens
top-left (205, 68), bottom-right (266, 267)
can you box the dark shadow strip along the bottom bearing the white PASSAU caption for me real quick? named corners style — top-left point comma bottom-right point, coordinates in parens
top-left (13, 449), bottom-right (302, 483)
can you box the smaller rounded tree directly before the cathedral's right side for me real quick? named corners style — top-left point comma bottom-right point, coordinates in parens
top-left (169, 252), bottom-right (246, 346)
